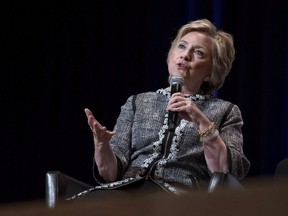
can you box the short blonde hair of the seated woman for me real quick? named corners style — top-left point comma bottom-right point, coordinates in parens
top-left (167, 19), bottom-right (235, 94)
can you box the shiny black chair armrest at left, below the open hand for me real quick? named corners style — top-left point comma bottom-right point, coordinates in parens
top-left (45, 171), bottom-right (93, 208)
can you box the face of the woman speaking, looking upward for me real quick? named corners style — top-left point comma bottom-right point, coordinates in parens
top-left (168, 32), bottom-right (213, 93)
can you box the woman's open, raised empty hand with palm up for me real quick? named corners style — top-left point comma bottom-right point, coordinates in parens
top-left (84, 108), bottom-right (116, 148)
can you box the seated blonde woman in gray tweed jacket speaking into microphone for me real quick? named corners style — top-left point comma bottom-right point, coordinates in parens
top-left (69, 19), bottom-right (250, 198)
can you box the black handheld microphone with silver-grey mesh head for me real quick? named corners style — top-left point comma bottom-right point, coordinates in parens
top-left (168, 76), bottom-right (184, 132)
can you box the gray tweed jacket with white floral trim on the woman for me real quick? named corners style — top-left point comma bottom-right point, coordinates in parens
top-left (73, 89), bottom-right (250, 197)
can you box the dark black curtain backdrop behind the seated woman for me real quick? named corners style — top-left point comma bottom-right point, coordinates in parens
top-left (0, 0), bottom-right (288, 203)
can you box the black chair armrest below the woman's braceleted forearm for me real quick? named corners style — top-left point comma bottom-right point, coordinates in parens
top-left (208, 172), bottom-right (244, 193)
